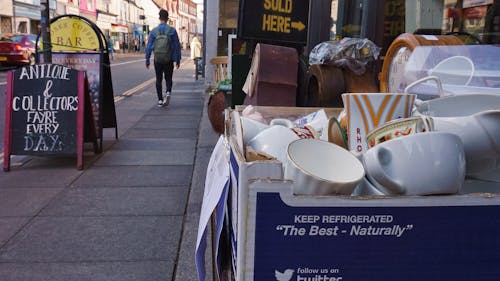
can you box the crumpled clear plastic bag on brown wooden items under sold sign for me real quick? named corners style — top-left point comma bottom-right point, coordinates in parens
top-left (309, 37), bottom-right (381, 75)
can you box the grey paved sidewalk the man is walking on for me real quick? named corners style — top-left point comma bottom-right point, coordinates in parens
top-left (0, 55), bottom-right (218, 281)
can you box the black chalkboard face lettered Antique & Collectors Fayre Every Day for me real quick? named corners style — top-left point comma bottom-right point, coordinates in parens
top-left (11, 64), bottom-right (78, 155)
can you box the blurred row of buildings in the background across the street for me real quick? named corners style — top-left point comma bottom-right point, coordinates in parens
top-left (0, 0), bottom-right (200, 52)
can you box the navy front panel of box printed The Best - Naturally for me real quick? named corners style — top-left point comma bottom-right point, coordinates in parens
top-left (250, 188), bottom-right (500, 281)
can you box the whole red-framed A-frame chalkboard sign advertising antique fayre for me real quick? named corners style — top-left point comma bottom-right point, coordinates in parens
top-left (4, 64), bottom-right (98, 171)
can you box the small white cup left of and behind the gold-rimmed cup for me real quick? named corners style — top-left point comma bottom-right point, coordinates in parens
top-left (247, 125), bottom-right (300, 163)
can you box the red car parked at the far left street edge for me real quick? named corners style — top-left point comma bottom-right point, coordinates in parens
top-left (0, 34), bottom-right (37, 65)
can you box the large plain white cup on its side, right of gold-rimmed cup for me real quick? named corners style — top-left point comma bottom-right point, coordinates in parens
top-left (363, 132), bottom-right (465, 195)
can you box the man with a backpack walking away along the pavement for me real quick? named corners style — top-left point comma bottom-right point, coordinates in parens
top-left (146, 9), bottom-right (181, 107)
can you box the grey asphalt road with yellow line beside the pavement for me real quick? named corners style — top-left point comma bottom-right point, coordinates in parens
top-left (0, 54), bottom-right (155, 154)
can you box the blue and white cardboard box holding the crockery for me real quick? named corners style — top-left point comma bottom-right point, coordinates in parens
top-left (226, 107), bottom-right (500, 281)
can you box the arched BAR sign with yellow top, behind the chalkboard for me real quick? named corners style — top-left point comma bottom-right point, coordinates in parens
top-left (36, 14), bottom-right (118, 152)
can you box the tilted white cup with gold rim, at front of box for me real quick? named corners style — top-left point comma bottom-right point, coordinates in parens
top-left (285, 139), bottom-right (365, 195)
